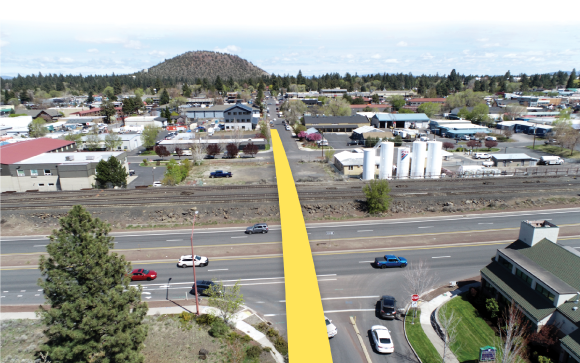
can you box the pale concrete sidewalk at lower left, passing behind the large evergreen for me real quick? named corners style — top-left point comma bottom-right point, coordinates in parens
top-left (0, 305), bottom-right (284, 363)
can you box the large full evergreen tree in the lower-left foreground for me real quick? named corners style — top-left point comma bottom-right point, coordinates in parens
top-left (38, 205), bottom-right (147, 363)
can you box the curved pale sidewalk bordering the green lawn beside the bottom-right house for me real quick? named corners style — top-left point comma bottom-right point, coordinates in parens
top-left (420, 282), bottom-right (479, 363)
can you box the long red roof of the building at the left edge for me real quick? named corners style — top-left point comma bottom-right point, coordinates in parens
top-left (0, 138), bottom-right (74, 164)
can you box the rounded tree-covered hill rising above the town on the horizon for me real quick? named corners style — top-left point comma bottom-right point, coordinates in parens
top-left (145, 51), bottom-right (268, 82)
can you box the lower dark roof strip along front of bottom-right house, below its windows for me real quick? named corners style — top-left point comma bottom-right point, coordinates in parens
top-left (481, 261), bottom-right (556, 321)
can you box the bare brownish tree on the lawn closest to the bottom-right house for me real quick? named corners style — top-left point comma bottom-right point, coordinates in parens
top-left (496, 301), bottom-right (529, 363)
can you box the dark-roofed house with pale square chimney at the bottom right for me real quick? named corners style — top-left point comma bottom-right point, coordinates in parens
top-left (481, 221), bottom-right (580, 363)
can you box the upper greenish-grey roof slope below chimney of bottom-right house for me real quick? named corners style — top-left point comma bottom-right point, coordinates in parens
top-left (506, 238), bottom-right (580, 293)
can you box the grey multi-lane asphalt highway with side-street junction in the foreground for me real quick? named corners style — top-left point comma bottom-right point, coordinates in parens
top-left (0, 208), bottom-right (580, 362)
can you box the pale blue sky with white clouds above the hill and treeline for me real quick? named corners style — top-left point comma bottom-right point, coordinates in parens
top-left (0, 0), bottom-right (580, 76)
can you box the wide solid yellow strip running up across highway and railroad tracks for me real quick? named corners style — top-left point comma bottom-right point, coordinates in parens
top-left (271, 130), bottom-right (332, 363)
